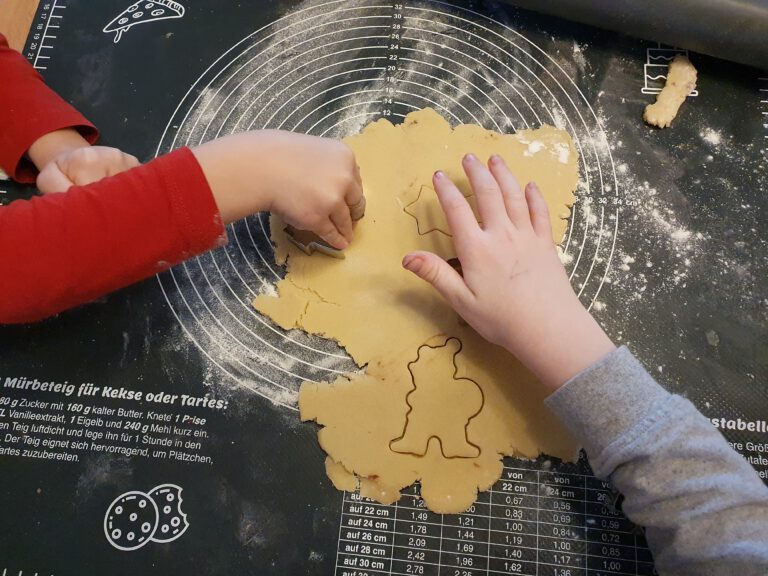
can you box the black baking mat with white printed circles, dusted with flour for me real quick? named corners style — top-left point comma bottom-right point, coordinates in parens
top-left (0, 0), bottom-right (768, 576)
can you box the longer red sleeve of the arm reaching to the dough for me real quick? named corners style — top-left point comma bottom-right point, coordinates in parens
top-left (0, 148), bottom-right (226, 324)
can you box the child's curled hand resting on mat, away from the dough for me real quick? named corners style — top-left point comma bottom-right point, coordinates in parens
top-left (37, 146), bottom-right (139, 194)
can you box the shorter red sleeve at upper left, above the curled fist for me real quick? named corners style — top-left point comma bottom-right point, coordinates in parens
top-left (0, 34), bottom-right (98, 182)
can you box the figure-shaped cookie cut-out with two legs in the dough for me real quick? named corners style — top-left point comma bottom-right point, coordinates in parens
top-left (389, 338), bottom-right (483, 458)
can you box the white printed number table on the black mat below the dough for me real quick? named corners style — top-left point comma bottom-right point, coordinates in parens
top-left (336, 464), bottom-right (656, 576)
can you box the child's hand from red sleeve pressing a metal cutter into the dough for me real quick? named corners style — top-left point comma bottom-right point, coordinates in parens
top-left (193, 130), bottom-right (363, 249)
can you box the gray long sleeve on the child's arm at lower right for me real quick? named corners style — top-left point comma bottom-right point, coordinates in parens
top-left (547, 347), bottom-right (768, 576)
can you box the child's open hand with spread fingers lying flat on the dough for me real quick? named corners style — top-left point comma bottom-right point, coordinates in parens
top-left (403, 155), bottom-right (614, 389)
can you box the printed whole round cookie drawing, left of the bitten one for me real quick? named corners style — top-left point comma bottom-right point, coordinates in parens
top-left (104, 490), bottom-right (160, 550)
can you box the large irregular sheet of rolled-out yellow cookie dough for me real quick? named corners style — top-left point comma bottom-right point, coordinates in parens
top-left (254, 109), bottom-right (578, 513)
